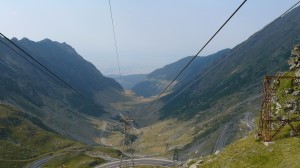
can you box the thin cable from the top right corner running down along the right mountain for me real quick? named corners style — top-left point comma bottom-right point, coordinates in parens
top-left (149, 1), bottom-right (300, 112)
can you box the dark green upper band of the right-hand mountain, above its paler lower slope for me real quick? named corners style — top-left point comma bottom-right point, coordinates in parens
top-left (164, 7), bottom-right (300, 119)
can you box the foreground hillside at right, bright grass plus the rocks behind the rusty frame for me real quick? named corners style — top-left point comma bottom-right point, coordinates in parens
top-left (184, 45), bottom-right (300, 167)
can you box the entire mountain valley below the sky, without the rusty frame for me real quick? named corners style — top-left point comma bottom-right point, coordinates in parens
top-left (0, 1), bottom-right (300, 168)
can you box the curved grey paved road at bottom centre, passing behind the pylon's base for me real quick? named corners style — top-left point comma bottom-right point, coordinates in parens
top-left (95, 158), bottom-right (180, 168)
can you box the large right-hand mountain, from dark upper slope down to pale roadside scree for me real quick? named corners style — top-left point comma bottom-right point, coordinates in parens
top-left (156, 4), bottom-right (300, 158)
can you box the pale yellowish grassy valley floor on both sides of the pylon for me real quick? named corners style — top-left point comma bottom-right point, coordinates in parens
top-left (103, 119), bottom-right (196, 157)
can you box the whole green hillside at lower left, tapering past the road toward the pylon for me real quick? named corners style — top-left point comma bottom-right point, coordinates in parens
top-left (0, 104), bottom-right (120, 168)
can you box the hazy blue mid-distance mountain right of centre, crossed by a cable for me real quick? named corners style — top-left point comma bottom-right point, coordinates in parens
top-left (132, 49), bottom-right (230, 97)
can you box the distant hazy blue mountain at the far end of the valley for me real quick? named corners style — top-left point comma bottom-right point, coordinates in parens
top-left (108, 74), bottom-right (147, 90)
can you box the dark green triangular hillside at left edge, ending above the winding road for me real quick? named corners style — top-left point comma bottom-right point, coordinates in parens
top-left (0, 104), bottom-right (81, 167)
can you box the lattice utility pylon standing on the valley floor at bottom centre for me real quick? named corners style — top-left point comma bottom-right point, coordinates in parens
top-left (120, 113), bottom-right (134, 168)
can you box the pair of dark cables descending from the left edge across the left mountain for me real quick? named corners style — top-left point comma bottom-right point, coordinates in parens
top-left (0, 33), bottom-right (102, 113)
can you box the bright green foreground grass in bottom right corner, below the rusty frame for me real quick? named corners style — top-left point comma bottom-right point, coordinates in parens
top-left (199, 131), bottom-right (300, 168)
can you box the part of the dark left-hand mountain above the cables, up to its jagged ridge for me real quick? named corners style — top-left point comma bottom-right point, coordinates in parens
top-left (13, 38), bottom-right (122, 107)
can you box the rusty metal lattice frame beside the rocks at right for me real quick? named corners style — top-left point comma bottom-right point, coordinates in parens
top-left (258, 75), bottom-right (300, 142)
